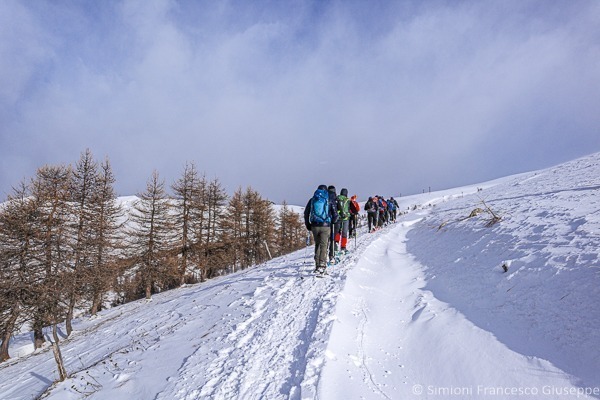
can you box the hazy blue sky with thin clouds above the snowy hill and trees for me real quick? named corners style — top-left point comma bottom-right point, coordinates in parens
top-left (0, 0), bottom-right (600, 205)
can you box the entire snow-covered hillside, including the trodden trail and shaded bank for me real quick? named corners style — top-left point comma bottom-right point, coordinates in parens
top-left (0, 154), bottom-right (600, 399)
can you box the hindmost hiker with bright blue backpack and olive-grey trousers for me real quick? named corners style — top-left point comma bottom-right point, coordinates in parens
top-left (304, 185), bottom-right (338, 274)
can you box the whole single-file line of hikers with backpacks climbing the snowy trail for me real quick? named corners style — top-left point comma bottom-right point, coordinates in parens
top-left (304, 185), bottom-right (398, 274)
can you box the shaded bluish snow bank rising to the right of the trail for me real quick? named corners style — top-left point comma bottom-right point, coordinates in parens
top-left (407, 154), bottom-right (600, 386)
